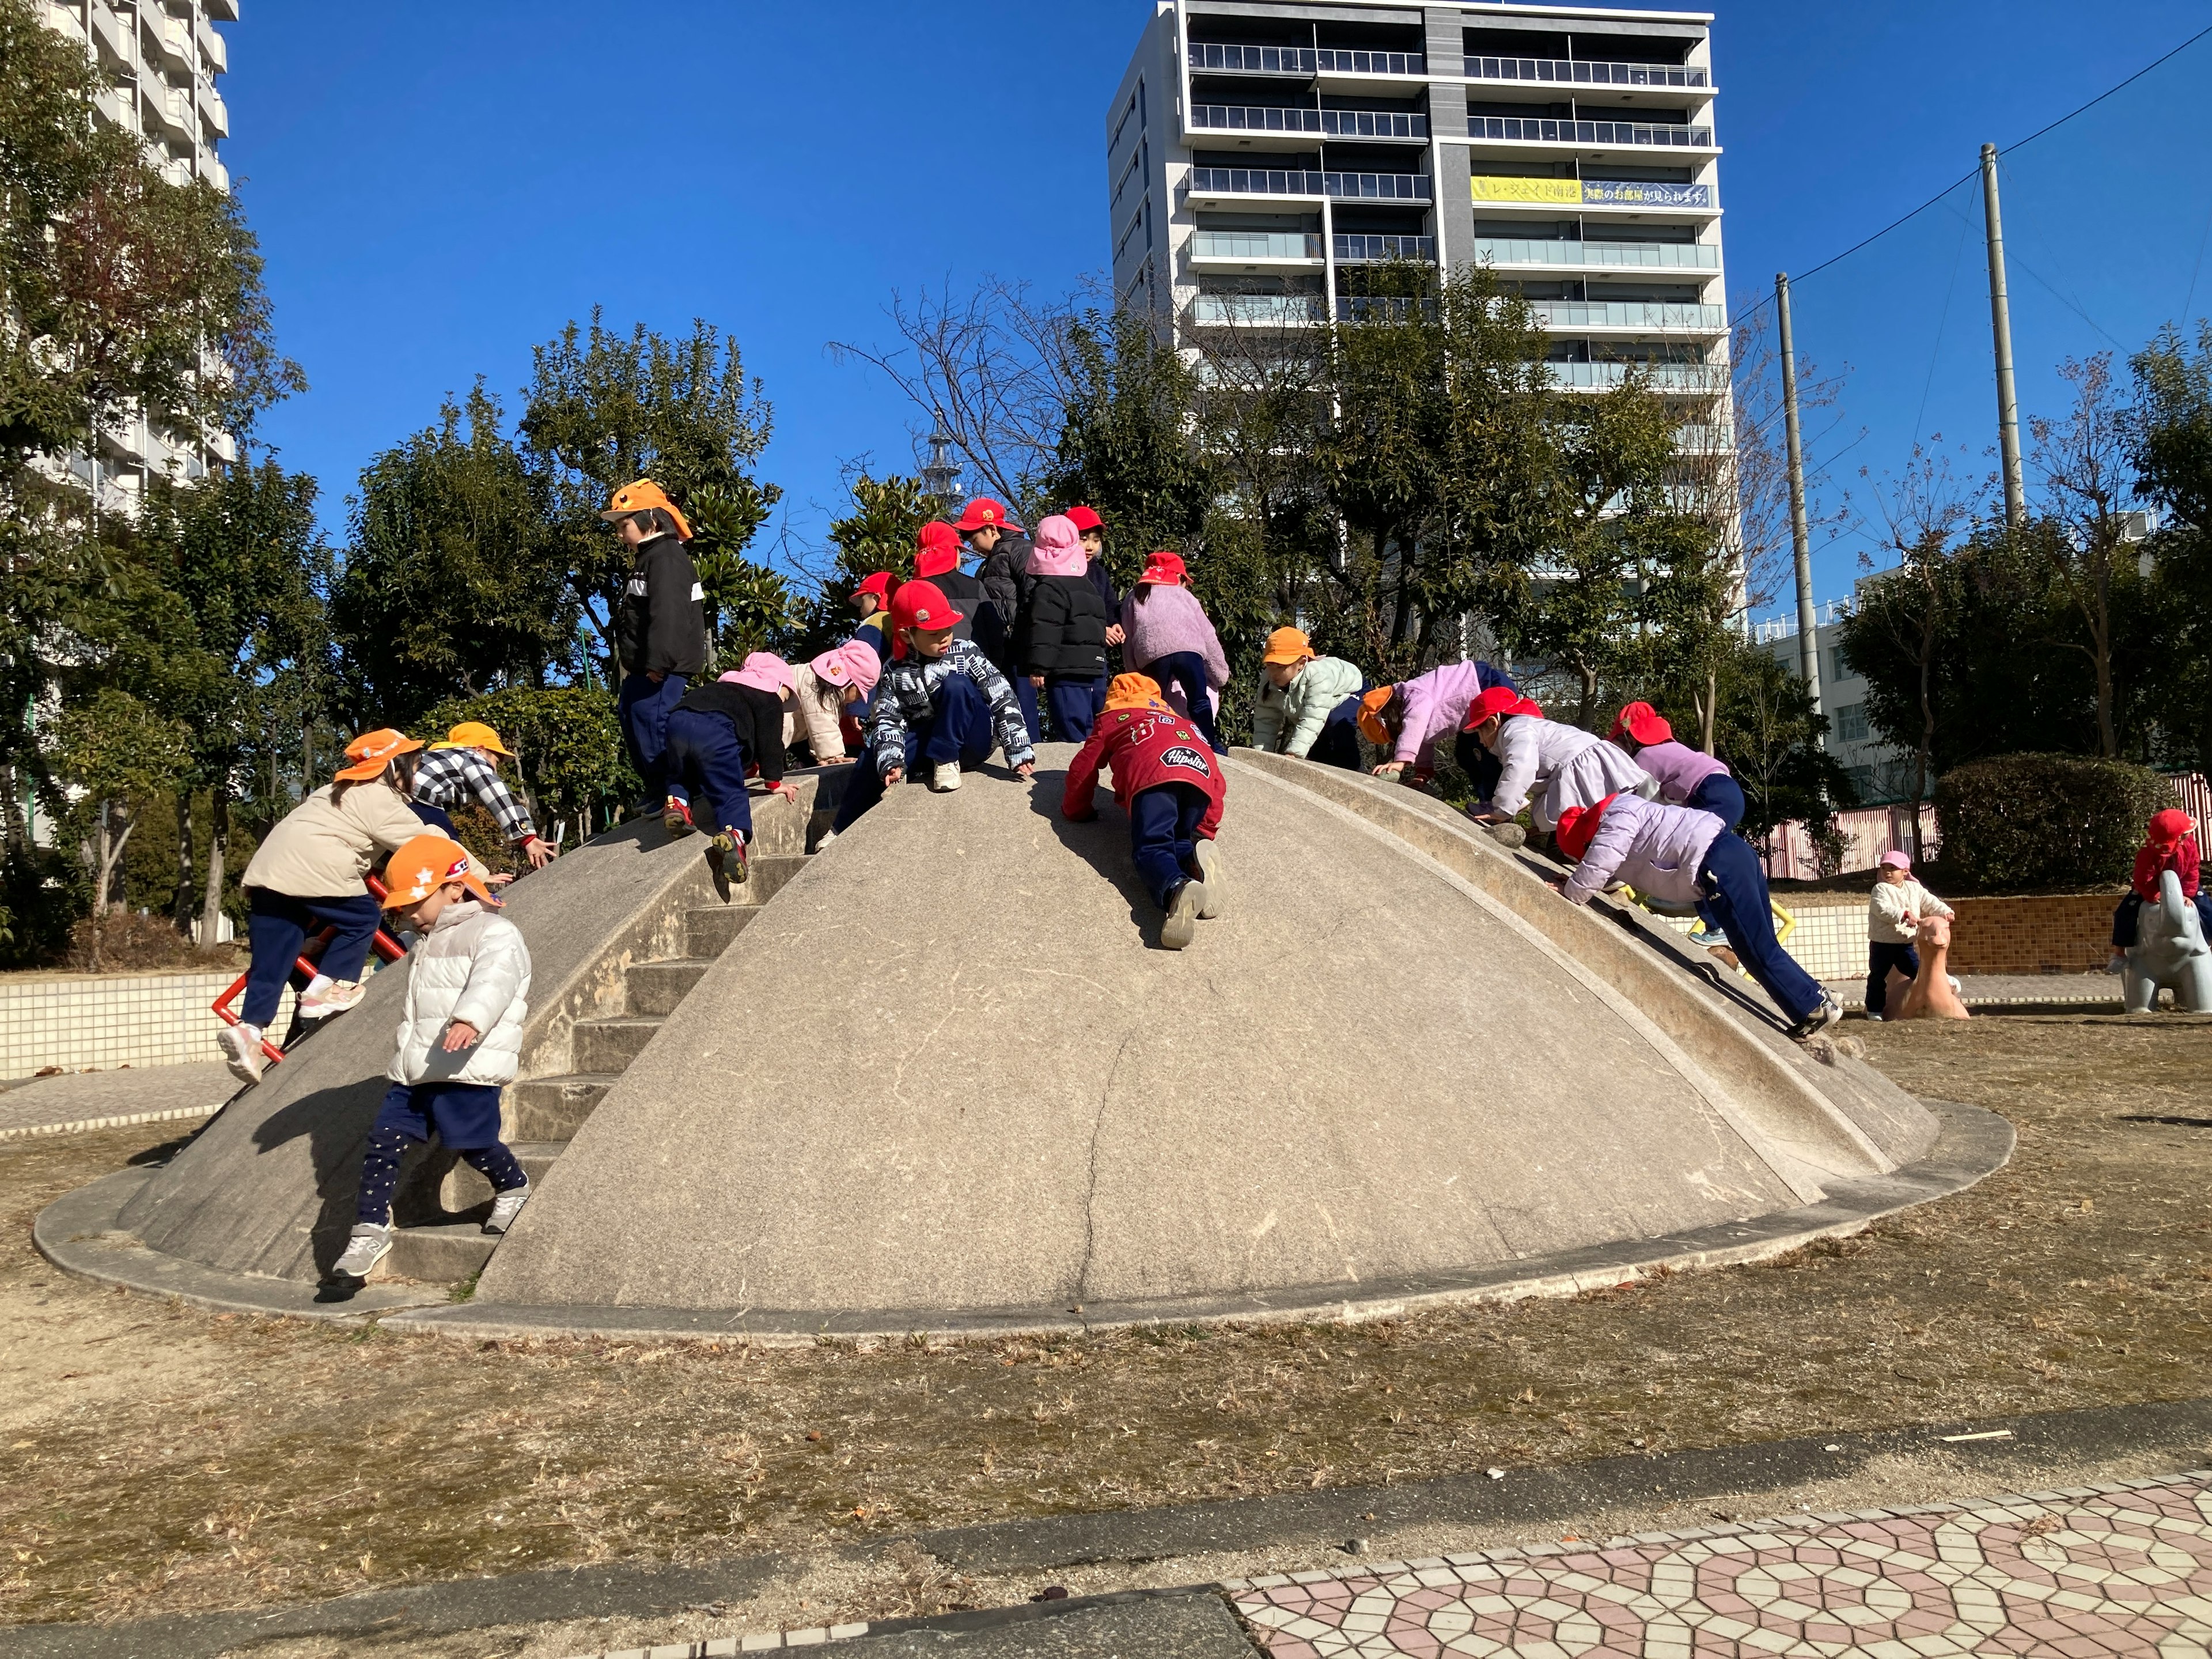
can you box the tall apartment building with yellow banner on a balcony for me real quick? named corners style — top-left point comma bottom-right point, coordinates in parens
top-left (1106, 0), bottom-right (1728, 392)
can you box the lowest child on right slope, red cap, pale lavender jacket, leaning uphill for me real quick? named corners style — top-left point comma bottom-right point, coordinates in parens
top-left (1559, 791), bottom-right (1843, 1040)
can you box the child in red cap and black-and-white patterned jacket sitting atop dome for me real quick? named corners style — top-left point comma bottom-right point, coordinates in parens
top-left (816, 582), bottom-right (1037, 851)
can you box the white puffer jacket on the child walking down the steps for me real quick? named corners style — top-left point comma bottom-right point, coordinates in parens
top-left (385, 898), bottom-right (531, 1084)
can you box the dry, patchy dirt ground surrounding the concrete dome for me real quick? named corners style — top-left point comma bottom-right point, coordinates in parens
top-left (0, 1016), bottom-right (2212, 1624)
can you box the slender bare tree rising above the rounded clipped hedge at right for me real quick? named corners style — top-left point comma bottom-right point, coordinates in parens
top-left (2028, 352), bottom-right (2135, 759)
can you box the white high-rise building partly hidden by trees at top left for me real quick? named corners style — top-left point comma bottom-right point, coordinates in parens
top-left (42, 0), bottom-right (239, 513)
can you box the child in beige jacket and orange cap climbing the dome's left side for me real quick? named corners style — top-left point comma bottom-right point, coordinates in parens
top-left (214, 726), bottom-right (422, 1084)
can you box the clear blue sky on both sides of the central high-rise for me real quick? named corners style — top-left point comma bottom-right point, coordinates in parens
top-left (224, 0), bottom-right (2212, 619)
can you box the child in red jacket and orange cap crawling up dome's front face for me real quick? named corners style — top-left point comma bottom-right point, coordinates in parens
top-left (1059, 675), bottom-right (1225, 951)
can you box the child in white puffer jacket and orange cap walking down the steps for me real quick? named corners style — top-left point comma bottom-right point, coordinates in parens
top-left (325, 836), bottom-right (531, 1290)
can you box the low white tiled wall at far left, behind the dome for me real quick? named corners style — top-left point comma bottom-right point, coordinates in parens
top-left (0, 974), bottom-right (292, 1077)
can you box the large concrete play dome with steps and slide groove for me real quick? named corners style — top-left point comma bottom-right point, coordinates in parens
top-left (37, 748), bottom-right (2011, 1340)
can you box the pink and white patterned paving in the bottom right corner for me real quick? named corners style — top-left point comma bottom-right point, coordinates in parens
top-left (1225, 1473), bottom-right (2212, 1659)
